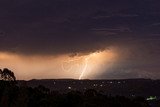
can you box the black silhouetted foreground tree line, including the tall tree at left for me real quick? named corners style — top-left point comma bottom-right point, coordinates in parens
top-left (0, 68), bottom-right (159, 107)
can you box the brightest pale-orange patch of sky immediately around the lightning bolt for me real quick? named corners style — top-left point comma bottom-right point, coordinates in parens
top-left (62, 51), bottom-right (115, 80)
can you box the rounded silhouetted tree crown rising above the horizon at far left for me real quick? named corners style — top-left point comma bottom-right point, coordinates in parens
top-left (0, 68), bottom-right (16, 81)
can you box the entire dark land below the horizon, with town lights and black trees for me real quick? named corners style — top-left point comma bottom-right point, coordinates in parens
top-left (0, 79), bottom-right (160, 107)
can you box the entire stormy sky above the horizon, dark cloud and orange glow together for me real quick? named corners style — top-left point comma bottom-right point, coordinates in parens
top-left (0, 0), bottom-right (160, 79)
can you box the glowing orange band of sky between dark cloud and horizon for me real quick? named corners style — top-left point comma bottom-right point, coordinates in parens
top-left (0, 50), bottom-right (117, 80)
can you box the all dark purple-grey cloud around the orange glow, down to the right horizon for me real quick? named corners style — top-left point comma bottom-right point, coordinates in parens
top-left (0, 0), bottom-right (160, 78)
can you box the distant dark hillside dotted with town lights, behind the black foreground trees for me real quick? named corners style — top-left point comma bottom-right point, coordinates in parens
top-left (19, 79), bottom-right (160, 97)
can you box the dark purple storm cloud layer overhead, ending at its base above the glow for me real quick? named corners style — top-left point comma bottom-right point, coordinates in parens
top-left (0, 0), bottom-right (160, 54)
